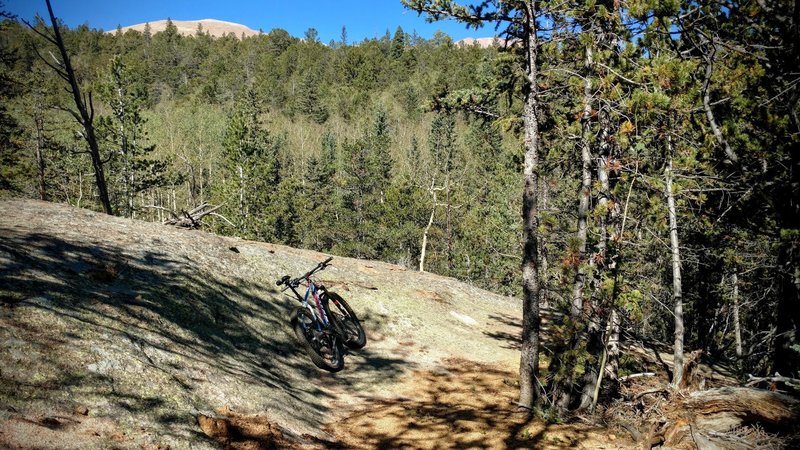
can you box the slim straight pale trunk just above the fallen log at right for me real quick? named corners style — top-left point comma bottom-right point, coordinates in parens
top-left (664, 134), bottom-right (684, 387)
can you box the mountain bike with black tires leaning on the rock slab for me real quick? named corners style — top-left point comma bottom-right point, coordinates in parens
top-left (276, 257), bottom-right (367, 372)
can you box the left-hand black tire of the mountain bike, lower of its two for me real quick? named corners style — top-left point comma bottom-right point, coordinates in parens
top-left (292, 306), bottom-right (344, 372)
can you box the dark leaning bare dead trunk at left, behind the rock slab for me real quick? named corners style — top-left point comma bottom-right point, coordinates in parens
top-left (41, 0), bottom-right (113, 214)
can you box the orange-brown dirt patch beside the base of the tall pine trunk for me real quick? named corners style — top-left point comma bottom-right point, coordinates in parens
top-left (328, 359), bottom-right (633, 449)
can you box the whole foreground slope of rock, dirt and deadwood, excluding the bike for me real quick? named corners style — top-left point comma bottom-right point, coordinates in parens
top-left (0, 200), bottom-right (797, 450)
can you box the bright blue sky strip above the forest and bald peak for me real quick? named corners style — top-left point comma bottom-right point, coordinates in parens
top-left (0, 0), bottom-right (494, 43)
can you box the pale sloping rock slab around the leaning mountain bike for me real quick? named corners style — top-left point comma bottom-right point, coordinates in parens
top-left (0, 200), bottom-right (612, 448)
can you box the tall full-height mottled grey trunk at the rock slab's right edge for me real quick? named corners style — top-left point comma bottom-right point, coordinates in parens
top-left (519, 0), bottom-right (541, 408)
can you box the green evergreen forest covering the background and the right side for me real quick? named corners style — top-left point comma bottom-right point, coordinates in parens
top-left (0, 0), bottom-right (800, 412)
